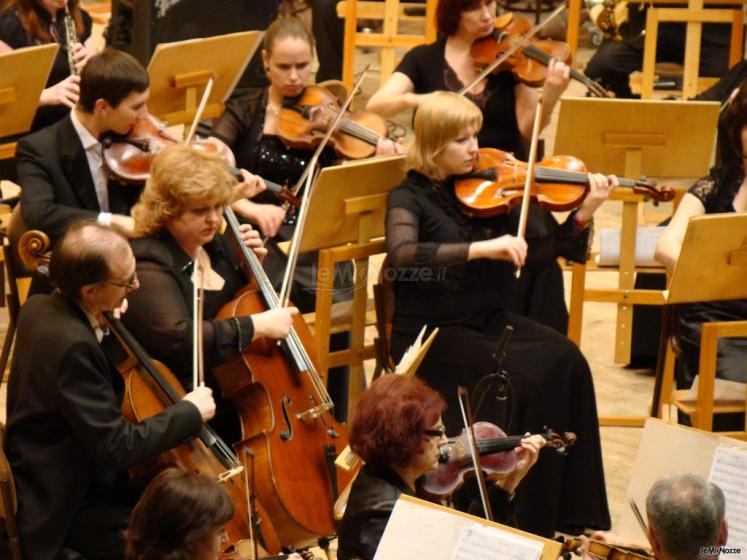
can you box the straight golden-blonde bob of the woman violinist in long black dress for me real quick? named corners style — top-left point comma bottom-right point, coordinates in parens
top-left (405, 91), bottom-right (482, 177)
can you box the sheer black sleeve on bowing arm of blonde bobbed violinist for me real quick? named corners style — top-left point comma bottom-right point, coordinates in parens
top-left (386, 207), bottom-right (470, 268)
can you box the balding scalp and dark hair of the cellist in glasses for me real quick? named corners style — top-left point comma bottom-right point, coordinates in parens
top-left (49, 220), bottom-right (132, 301)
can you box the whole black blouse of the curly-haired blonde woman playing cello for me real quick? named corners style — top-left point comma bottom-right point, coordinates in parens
top-left (122, 230), bottom-right (254, 387)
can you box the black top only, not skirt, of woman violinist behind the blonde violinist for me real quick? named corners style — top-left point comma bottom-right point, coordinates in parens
top-left (395, 37), bottom-right (525, 160)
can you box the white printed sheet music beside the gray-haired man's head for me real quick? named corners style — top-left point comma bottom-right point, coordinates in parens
top-left (708, 447), bottom-right (747, 558)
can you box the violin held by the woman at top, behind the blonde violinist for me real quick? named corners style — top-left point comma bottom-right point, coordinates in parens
top-left (470, 13), bottom-right (611, 97)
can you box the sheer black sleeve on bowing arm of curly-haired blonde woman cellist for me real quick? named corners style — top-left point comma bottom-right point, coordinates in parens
top-left (124, 262), bottom-right (254, 386)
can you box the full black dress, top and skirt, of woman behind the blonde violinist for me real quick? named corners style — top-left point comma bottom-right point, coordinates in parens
top-left (395, 37), bottom-right (572, 334)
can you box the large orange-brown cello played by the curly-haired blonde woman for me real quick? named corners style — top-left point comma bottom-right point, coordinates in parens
top-left (214, 207), bottom-right (350, 546)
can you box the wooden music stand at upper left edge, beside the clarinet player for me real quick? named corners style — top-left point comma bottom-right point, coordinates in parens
top-left (0, 43), bottom-right (60, 159)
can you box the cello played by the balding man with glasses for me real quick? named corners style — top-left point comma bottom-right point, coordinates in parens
top-left (104, 313), bottom-right (280, 560)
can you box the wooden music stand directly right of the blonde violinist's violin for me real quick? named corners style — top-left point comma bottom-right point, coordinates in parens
top-left (555, 98), bottom-right (719, 363)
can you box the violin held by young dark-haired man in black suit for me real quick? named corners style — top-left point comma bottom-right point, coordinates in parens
top-left (101, 115), bottom-right (298, 206)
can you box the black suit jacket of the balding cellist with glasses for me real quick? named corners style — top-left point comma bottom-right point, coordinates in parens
top-left (7, 293), bottom-right (202, 560)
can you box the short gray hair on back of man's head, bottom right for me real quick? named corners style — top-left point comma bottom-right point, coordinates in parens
top-left (646, 474), bottom-right (725, 560)
